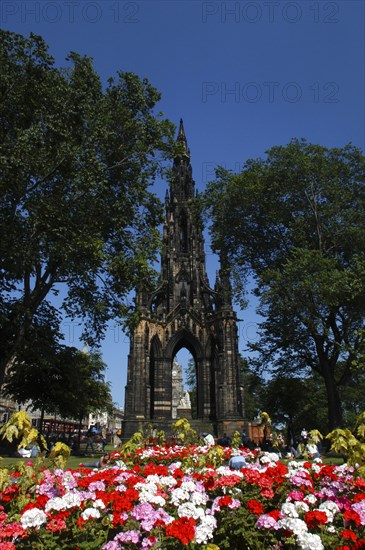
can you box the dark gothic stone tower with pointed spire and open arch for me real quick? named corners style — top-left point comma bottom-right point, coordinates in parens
top-left (123, 121), bottom-right (243, 438)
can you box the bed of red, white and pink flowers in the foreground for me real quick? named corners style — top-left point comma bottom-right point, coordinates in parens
top-left (0, 446), bottom-right (365, 550)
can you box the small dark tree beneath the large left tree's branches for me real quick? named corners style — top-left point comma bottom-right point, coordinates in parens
top-left (3, 314), bottom-right (112, 436)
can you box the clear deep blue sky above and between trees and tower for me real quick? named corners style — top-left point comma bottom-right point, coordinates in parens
top-left (0, 0), bottom-right (365, 405)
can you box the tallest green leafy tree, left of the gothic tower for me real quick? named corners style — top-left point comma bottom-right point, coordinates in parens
top-left (0, 31), bottom-right (173, 386)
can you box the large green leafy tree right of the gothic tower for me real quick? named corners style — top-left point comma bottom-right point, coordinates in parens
top-left (206, 140), bottom-right (365, 429)
